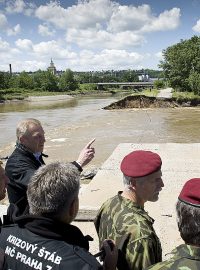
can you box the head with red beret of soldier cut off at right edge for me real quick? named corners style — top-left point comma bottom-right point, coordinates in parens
top-left (176, 178), bottom-right (200, 246)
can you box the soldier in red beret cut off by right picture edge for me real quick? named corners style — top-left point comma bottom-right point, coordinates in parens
top-left (147, 178), bottom-right (200, 270)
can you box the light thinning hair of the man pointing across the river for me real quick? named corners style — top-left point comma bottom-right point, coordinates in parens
top-left (16, 118), bottom-right (41, 142)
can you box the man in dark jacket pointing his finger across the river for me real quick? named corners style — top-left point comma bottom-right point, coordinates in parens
top-left (5, 118), bottom-right (94, 206)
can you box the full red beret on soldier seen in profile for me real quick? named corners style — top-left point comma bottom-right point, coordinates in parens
top-left (121, 150), bottom-right (162, 177)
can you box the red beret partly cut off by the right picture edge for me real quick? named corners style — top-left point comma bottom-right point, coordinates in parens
top-left (178, 178), bottom-right (200, 207)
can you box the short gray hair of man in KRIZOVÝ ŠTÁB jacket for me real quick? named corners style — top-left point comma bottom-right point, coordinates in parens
top-left (27, 162), bottom-right (80, 217)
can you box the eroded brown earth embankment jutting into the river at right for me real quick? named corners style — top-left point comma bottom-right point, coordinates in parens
top-left (103, 95), bottom-right (200, 110)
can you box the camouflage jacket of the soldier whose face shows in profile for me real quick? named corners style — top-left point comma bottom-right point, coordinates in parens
top-left (94, 192), bottom-right (162, 270)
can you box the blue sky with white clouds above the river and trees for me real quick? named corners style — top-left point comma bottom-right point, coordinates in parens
top-left (0, 0), bottom-right (200, 71)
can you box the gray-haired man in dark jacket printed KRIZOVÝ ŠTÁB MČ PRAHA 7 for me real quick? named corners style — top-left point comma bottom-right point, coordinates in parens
top-left (0, 162), bottom-right (117, 270)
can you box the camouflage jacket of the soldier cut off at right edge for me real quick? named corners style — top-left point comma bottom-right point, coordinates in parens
top-left (147, 244), bottom-right (200, 270)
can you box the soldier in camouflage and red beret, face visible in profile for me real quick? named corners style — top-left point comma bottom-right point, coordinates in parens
top-left (95, 151), bottom-right (164, 270)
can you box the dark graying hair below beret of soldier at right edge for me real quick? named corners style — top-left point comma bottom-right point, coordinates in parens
top-left (176, 200), bottom-right (200, 246)
